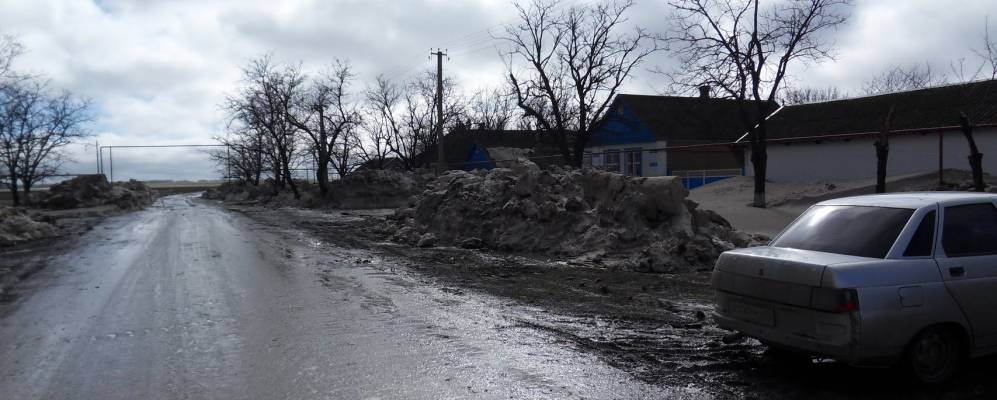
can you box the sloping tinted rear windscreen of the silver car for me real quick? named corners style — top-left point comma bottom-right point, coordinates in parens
top-left (772, 206), bottom-right (914, 258)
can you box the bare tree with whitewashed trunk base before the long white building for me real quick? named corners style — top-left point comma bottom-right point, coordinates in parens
top-left (670, 0), bottom-right (849, 207)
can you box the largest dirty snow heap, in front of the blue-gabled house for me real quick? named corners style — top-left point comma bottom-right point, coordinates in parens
top-left (390, 160), bottom-right (750, 272)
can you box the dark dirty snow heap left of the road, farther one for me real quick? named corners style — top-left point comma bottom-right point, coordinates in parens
top-left (38, 174), bottom-right (153, 210)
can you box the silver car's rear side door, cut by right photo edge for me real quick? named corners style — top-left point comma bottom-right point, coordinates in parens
top-left (936, 202), bottom-right (997, 347)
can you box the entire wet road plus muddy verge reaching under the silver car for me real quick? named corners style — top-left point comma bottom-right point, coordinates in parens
top-left (0, 195), bottom-right (997, 399)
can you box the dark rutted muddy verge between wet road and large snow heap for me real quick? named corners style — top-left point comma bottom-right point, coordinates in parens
top-left (228, 205), bottom-right (997, 399)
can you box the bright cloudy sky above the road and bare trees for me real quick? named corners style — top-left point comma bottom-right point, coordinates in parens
top-left (0, 0), bottom-right (997, 180)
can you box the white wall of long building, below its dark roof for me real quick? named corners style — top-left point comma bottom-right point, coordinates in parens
top-left (745, 128), bottom-right (997, 182)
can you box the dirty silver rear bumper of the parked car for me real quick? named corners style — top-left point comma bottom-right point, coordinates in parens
top-left (714, 291), bottom-right (863, 365)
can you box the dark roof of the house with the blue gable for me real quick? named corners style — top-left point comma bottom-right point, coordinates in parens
top-left (597, 94), bottom-right (777, 144)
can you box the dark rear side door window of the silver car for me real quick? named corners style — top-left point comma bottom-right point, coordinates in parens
top-left (942, 203), bottom-right (997, 257)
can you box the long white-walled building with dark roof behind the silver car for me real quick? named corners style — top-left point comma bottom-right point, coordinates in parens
top-left (738, 80), bottom-right (997, 182)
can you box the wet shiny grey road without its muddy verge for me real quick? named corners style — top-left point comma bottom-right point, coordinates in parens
top-left (0, 196), bottom-right (688, 399)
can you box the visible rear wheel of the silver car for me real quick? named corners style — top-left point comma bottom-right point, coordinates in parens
top-left (906, 326), bottom-right (965, 384)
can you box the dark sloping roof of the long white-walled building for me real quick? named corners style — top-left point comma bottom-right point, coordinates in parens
top-left (767, 80), bottom-right (997, 140)
